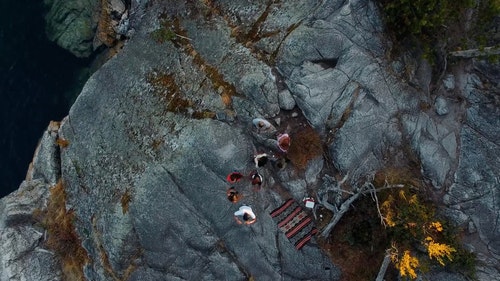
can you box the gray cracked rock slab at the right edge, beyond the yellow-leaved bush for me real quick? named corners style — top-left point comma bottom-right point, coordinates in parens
top-left (446, 71), bottom-right (500, 280)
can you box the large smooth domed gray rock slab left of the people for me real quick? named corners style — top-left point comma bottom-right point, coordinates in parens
top-left (52, 1), bottom-right (339, 280)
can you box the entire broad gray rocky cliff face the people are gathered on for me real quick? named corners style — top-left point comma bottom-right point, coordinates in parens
top-left (0, 1), bottom-right (500, 280)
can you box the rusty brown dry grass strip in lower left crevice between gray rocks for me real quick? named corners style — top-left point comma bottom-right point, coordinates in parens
top-left (39, 181), bottom-right (89, 281)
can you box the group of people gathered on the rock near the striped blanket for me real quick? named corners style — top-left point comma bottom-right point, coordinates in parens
top-left (226, 118), bottom-right (290, 225)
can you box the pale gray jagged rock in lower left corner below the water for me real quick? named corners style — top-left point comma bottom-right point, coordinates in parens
top-left (0, 126), bottom-right (61, 280)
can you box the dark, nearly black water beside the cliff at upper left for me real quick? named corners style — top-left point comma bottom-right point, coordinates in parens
top-left (0, 0), bottom-right (88, 197)
